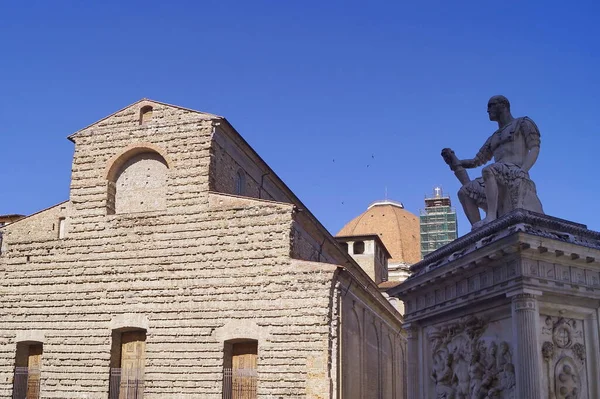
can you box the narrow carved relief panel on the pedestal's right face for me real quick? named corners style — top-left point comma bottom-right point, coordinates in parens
top-left (540, 315), bottom-right (588, 399)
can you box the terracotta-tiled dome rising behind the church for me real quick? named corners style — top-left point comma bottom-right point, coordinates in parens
top-left (337, 200), bottom-right (421, 264)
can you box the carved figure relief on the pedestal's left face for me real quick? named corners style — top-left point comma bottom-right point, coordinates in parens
top-left (428, 317), bottom-right (515, 399)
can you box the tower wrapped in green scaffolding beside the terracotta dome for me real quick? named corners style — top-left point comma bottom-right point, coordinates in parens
top-left (419, 187), bottom-right (458, 257)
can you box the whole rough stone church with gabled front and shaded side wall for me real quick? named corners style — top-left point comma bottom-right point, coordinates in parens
top-left (0, 100), bottom-right (406, 399)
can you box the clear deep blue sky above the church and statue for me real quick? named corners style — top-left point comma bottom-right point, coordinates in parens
top-left (0, 0), bottom-right (600, 238)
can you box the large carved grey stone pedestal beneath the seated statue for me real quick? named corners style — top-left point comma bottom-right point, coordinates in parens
top-left (388, 209), bottom-right (600, 399)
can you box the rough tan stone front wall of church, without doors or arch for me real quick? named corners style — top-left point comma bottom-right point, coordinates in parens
top-left (0, 101), bottom-right (406, 399)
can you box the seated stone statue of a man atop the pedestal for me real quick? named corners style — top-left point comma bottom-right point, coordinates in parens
top-left (442, 96), bottom-right (544, 230)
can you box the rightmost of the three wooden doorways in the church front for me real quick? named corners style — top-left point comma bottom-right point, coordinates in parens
top-left (223, 341), bottom-right (258, 399)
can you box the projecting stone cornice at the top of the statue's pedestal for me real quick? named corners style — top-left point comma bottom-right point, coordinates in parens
top-left (387, 209), bottom-right (600, 323)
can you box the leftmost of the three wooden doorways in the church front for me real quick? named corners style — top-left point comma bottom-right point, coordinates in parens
top-left (13, 342), bottom-right (43, 399)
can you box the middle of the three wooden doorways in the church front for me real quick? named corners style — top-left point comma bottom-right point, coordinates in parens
top-left (109, 330), bottom-right (146, 399)
